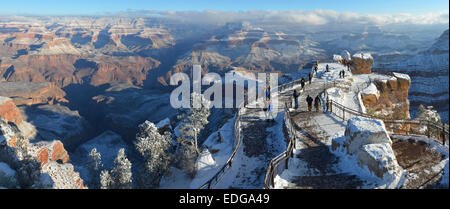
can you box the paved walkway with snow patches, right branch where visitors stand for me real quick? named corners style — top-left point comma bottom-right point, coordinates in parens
top-left (278, 76), bottom-right (363, 189)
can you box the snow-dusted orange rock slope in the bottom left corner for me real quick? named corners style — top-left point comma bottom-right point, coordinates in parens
top-left (0, 97), bottom-right (86, 189)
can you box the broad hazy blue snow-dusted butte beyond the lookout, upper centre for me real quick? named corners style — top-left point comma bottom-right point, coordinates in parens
top-left (158, 25), bottom-right (327, 84)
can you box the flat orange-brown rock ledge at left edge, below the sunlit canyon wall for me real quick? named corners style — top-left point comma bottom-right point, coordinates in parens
top-left (0, 82), bottom-right (68, 105)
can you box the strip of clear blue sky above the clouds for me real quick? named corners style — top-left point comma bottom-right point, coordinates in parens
top-left (0, 0), bottom-right (449, 15)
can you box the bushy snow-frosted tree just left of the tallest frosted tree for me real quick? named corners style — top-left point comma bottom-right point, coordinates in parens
top-left (135, 121), bottom-right (172, 188)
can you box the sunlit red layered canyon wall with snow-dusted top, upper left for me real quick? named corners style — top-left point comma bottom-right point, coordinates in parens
top-left (0, 18), bottom-right (167, 87)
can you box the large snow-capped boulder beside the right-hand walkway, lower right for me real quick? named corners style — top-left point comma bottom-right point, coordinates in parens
top-left (331, 117), bottom-right (404, 188)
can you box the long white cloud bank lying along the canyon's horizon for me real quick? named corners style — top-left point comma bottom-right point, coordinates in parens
top-left (129, 10), bottom-right (449, 25)
